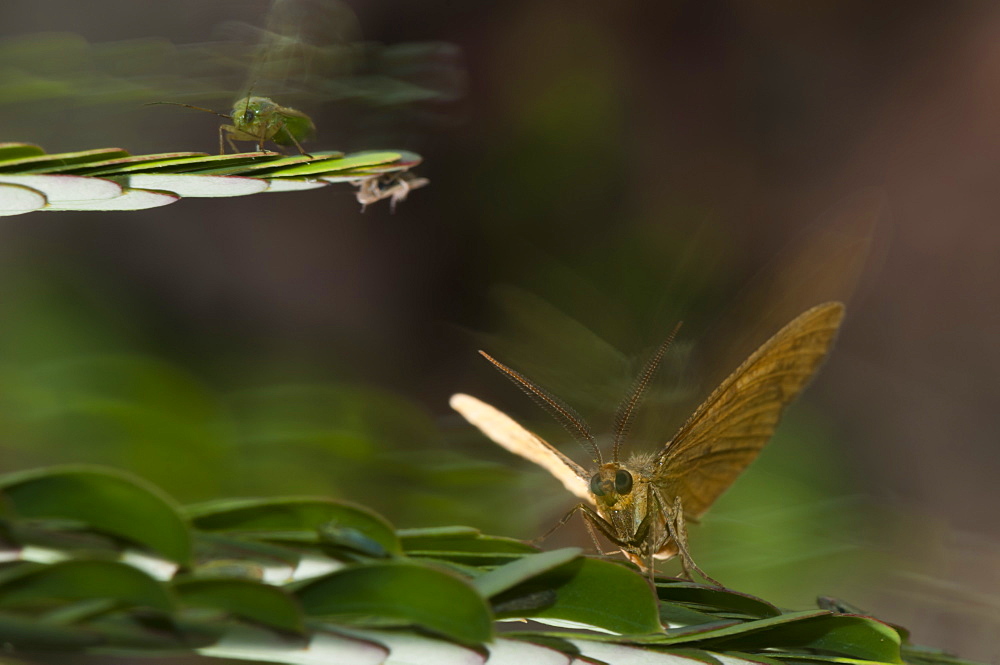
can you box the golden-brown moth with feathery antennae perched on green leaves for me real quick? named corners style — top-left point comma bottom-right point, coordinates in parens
top-left (450, 302), bottom-right (844, 586)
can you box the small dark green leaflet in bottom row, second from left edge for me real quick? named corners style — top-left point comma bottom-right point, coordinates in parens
top-left (173, 578), bottom-right (304, 633)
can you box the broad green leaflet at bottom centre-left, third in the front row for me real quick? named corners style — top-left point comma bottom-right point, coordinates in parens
top-left (296, 561), bottom-right (493, 644)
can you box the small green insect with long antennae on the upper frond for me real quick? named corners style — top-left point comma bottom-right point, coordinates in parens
top-left (146, 96), bottom-right (316, 155)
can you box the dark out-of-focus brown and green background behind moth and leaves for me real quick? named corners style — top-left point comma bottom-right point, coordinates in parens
top-left (0, 0), bottom-right (1000, 660)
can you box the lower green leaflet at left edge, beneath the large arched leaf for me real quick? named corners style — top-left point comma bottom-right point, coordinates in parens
top-left (0, 561), bottom-right (174, 612)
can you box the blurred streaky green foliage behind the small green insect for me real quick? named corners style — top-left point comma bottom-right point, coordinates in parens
top-left (0, 0), bottom-right (465, 150)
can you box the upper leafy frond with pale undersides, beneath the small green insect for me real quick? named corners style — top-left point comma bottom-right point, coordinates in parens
top-left (0, 143), bottom-right (427, 216)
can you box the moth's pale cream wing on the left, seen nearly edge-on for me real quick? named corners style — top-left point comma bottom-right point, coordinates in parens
top-left (449, 393), bottom-right (594, 506)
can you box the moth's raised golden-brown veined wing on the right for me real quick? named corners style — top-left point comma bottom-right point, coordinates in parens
top-left (654, 303), bottom-right (844, 518)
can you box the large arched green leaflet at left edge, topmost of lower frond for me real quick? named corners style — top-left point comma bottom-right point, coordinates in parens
top-left (0, 466), bottom-right (191, 565)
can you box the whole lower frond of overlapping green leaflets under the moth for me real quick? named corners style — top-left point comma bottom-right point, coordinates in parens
top-left (0, 462), bottom-right (961, 664)
